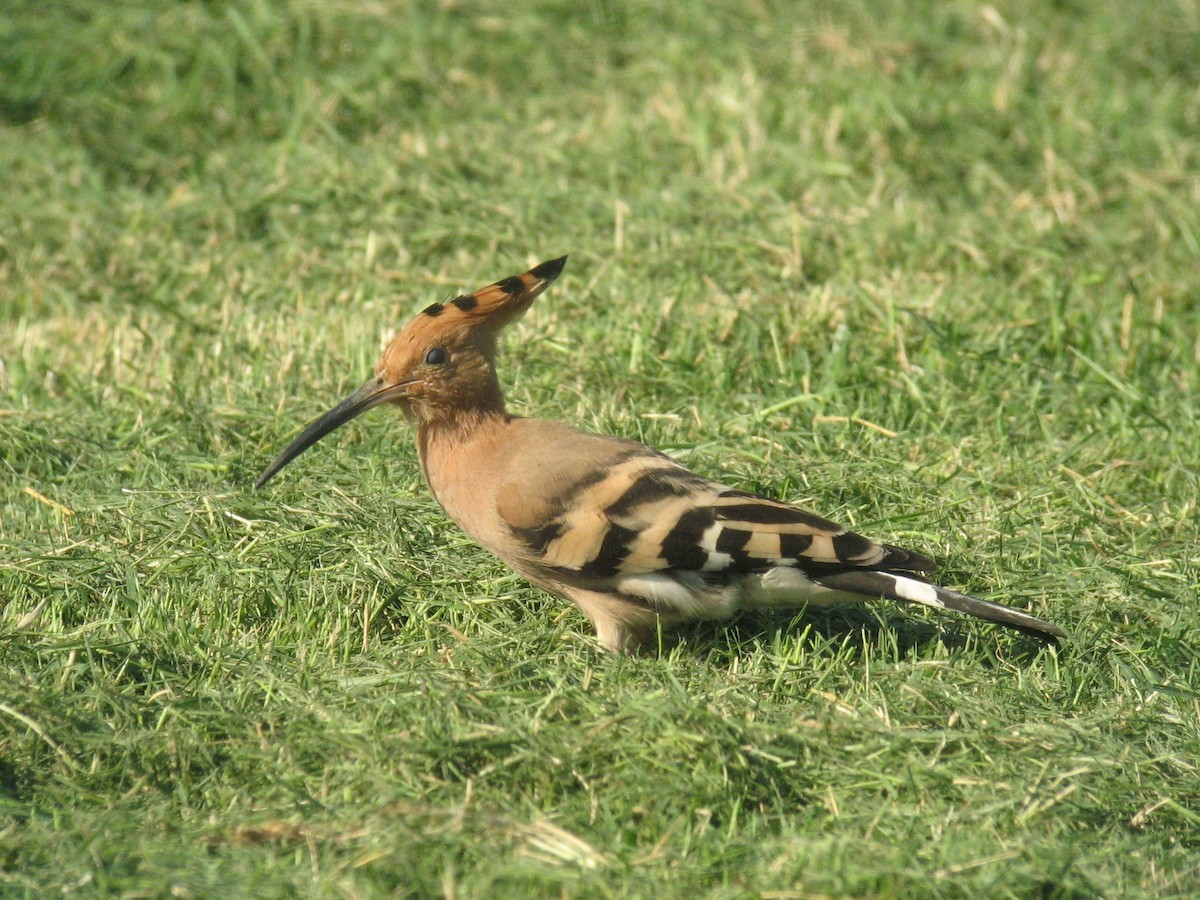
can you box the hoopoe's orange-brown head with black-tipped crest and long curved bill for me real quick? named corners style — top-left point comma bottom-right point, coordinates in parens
top-left (254, 257), bottom-right (566, 487)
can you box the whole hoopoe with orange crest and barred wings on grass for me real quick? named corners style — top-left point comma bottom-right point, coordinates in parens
top-left (254, 256), bottom-right (1066, 654)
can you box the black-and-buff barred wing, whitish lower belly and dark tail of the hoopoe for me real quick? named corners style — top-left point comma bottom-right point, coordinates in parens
top-left (501, 445), bottom-right (1058, 636)
